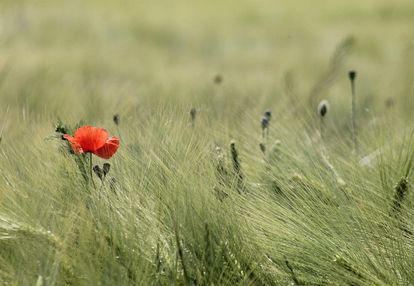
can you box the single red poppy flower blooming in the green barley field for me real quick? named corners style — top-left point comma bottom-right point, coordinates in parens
top-left (63, 126), bottom-right (119, 159)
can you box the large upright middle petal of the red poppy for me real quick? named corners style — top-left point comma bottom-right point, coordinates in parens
top-left (74, 126), bottom-right (108, 153)
